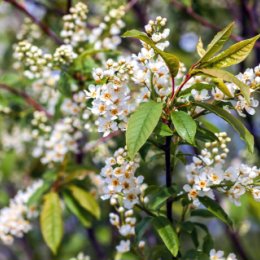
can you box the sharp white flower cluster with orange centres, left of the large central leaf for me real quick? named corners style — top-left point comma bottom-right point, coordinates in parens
top-left (85, 59), bottom-right (135, 136)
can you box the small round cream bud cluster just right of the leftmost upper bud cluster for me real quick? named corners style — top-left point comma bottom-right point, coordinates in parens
top-left (53, 45), bottom-right (78, 66)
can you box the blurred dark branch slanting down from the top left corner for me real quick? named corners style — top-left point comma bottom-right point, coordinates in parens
top-left (4, 0), bottom-right (63, 45)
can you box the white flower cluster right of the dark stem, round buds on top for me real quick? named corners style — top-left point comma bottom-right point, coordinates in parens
top-left (183, 132), bottom-right (260, 206)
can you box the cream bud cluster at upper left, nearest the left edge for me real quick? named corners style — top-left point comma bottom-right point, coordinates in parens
top-left (14, 41), bottom-right (52, 79)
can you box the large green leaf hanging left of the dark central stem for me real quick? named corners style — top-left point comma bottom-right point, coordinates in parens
top-left (126, 101), bottom-right (163, 160)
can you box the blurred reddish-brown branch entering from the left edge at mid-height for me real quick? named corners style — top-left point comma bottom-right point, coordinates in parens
top-left (0, 84), bottom-right (52, 118)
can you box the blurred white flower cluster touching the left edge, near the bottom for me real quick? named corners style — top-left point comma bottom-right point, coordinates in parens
top-left (0, 180), bottom-right (43, 245)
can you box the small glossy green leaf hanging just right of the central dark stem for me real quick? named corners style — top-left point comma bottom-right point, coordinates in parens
top-left (171, 111), bottom-right (197, 145)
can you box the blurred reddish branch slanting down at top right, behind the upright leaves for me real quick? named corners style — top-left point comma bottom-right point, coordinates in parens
top-left (171, 0), bottom-right (260, 48)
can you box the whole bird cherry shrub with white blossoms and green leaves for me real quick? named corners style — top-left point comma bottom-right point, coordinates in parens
top-left (0, 1), bottom-right (260, 260)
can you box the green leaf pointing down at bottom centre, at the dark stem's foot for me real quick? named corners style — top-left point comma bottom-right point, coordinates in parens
top-left (152, 216), bottom-right (179, 257)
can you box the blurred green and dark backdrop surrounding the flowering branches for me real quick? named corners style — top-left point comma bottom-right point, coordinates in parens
top-left (0, 0), bottom-right (260, 260)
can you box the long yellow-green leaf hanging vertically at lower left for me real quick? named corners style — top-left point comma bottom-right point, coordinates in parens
top-left (40, 192), bottom-right (63, 254)
